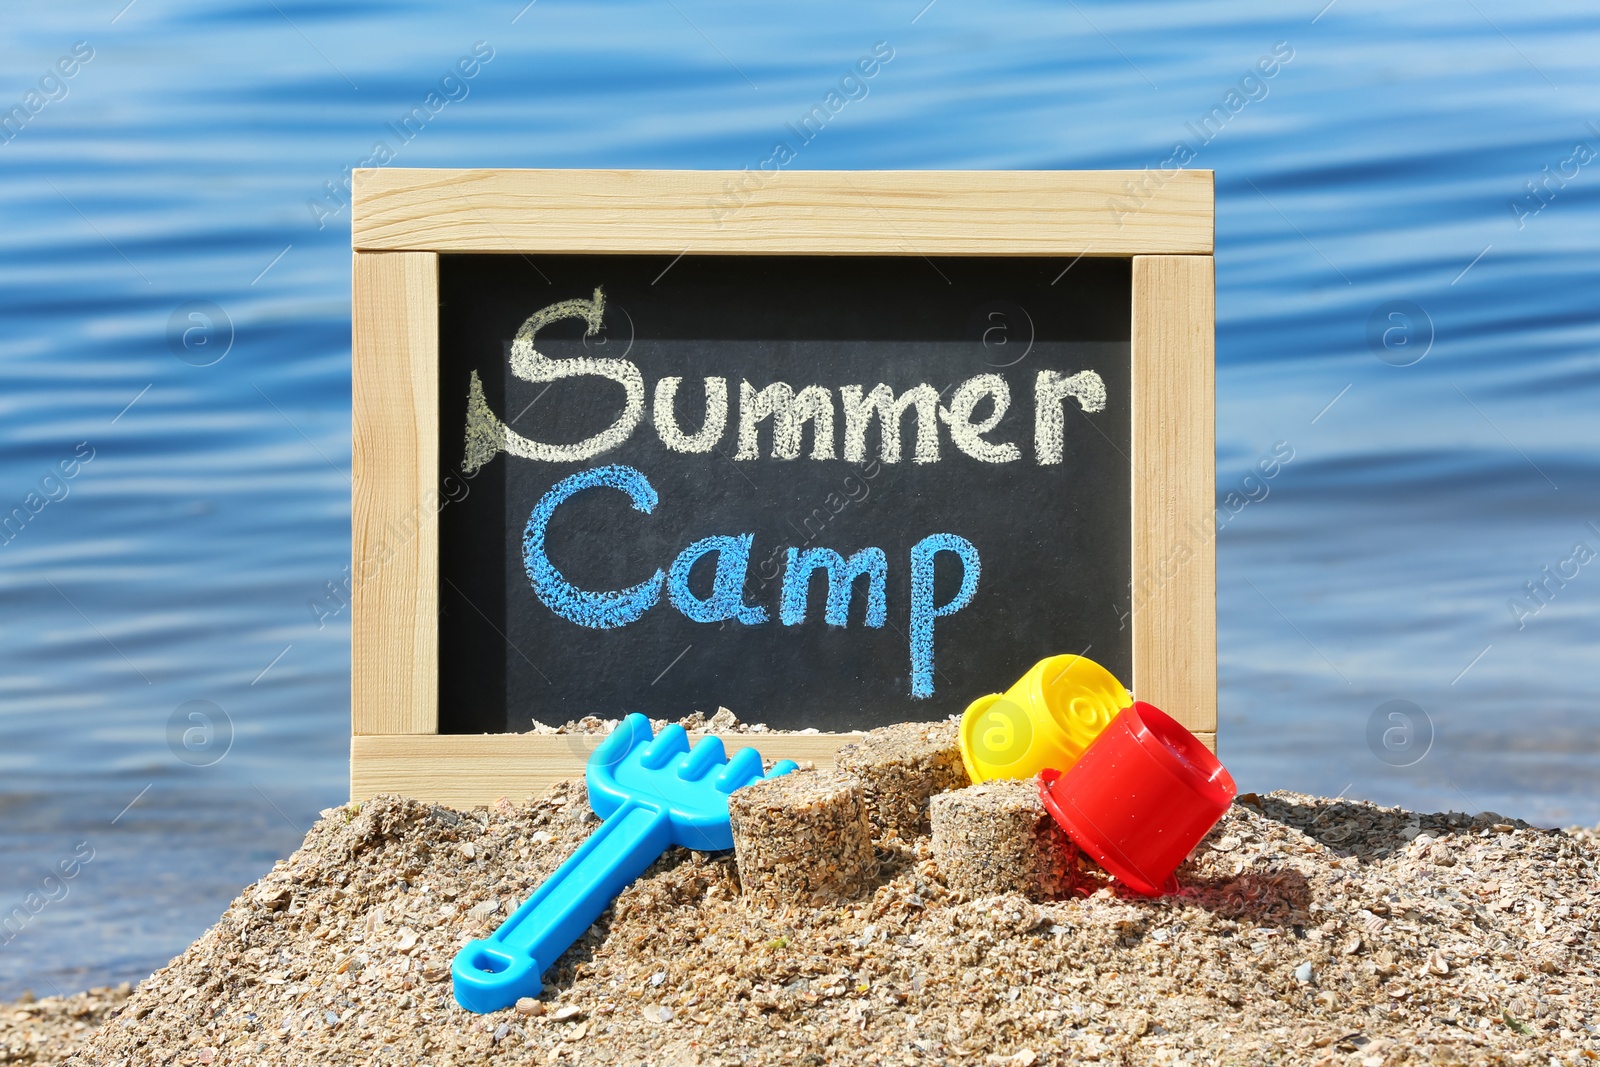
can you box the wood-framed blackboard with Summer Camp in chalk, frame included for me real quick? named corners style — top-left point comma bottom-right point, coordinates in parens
top-left (347, 166), bottom-right (1216, 806)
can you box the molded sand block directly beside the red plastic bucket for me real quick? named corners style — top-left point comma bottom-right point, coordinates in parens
top-left (934, 779), bottom-right (1077, 901)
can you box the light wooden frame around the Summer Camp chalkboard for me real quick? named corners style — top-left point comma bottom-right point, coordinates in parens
top-left (350, 170), bottom-right (1216, 806)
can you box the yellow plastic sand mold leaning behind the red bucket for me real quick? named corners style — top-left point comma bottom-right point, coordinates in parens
top-left (960, 656), bottom-right (1133, 782)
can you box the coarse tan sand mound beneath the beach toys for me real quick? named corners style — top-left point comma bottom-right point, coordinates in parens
top-left (62, 782), bottom-right (1600, 1067)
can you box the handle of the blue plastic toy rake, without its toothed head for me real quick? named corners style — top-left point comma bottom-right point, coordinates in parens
top-left (450, 800), bottom-right (672, 1013)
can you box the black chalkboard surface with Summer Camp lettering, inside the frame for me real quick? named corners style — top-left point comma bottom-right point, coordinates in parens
top-left (438, 254), bottom-right (1131, 733)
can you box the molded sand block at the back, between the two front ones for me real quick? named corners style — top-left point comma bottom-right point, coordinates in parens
top-left (834, 721), bottom-right (970, 841)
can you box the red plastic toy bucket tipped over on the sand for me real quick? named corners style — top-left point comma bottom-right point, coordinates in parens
top-left (1038, 701), bottom-right (1238, 896)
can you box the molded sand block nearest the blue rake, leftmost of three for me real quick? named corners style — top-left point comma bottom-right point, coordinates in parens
top-left (728, 771), bottom-right (878, 905)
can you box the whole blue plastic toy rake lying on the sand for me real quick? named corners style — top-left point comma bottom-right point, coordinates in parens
top-left (450, 715), bottom-right (797, 1013)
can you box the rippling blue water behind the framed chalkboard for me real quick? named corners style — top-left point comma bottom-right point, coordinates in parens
top-left (0, 0), bottom-right (1600, 997)
